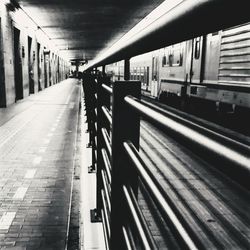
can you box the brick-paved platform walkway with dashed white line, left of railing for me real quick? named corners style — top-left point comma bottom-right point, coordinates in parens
top-left (0, 79), bottom-right (102, 250)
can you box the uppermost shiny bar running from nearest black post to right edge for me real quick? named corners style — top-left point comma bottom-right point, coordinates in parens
top-left (124, 96), bottom-right (250, 175)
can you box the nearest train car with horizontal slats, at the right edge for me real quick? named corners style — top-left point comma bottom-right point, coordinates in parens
top-left (187, 24), bottom-right (250, 112)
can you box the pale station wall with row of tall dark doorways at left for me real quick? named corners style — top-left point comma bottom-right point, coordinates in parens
top-left (0, 2), bottom-right (69, 107)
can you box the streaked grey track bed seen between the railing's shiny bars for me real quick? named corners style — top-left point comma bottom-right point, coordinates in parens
top-left (139, 114), bottom-right (250, 249)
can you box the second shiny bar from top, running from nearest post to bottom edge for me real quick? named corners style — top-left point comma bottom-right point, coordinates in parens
top-left (123, 142), bottom-right (198, 250)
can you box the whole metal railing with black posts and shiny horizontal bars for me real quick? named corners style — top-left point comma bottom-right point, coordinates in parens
top-left (84, 73), bottom-right (250, 249)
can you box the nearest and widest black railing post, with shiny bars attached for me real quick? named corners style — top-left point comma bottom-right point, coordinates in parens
top-left (110, 81), bottom-right (141, 250)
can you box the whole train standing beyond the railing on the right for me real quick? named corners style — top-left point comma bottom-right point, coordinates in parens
top-left (106, 23), bottom-right (250, 113)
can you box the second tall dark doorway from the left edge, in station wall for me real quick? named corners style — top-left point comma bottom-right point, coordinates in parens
top-left (14, 28), bottom-right (23, 101)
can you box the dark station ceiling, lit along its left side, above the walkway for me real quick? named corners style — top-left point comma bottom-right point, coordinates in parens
top-left (18, 0), bottom-right (163, 60)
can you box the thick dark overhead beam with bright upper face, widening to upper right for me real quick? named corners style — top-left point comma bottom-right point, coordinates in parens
top-left (85, 0), bottom-right (250, 70)
